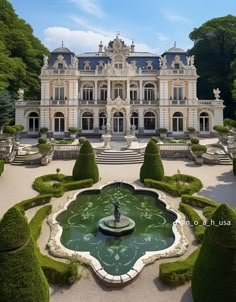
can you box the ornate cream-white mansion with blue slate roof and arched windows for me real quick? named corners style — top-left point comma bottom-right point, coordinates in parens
top-left (16, 36), bottom-right (224, 135)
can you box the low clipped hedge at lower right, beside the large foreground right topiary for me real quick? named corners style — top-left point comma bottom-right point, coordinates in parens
top-left (159, 247), bottom-right (200, 286)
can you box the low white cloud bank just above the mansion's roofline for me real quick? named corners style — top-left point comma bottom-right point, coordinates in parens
top-left (44, 27), bottom-right (159, 54)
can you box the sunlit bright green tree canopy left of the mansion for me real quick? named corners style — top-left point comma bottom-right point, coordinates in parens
top-left (0, 0), bottom-right (49, 99)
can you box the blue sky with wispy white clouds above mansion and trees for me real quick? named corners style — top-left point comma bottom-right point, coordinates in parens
top-left (10, 0), bottom-right (236, 54)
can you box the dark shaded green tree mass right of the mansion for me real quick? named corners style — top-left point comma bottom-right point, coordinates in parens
top-left (189, 15), bottom-right (236, 116)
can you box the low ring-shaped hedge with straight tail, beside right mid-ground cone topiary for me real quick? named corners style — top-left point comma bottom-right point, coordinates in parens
top-left (144, 174), bottom-right (202, 197)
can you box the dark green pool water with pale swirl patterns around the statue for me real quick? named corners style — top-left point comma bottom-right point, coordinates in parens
top-left (57, 183), bottom-right (176, 275)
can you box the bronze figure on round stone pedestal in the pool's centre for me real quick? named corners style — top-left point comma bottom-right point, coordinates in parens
top-left (98, 201), bottom-right (135, 236)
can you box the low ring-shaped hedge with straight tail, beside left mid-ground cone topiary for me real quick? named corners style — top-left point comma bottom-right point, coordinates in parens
top-left (33, 174), bottom-right (93, 197)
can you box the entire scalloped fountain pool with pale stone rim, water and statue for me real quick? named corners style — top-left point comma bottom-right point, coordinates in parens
top-left (48, 182), bottom-right (187, 285)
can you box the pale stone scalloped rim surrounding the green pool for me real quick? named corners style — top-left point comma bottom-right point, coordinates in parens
top-left (47, 181), bottom-right (188, 286)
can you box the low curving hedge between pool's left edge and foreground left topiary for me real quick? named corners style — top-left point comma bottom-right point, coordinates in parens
top-left (29, 205), bottom-right (80, 285)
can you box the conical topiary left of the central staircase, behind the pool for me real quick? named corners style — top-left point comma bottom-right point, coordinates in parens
top-left (72, 140), bottom-right (99, 183)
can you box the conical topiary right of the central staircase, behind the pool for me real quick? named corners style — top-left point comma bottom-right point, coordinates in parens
top-left (140, 140), bottom-right (164, 182)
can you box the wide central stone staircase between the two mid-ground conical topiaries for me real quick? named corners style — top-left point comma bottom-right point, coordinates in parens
top-left (96, 150), bottom-right (143, 165)
